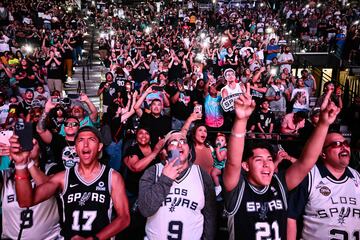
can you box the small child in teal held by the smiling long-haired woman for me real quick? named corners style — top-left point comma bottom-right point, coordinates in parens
top-left (211, 133), bottom-right (227, 196)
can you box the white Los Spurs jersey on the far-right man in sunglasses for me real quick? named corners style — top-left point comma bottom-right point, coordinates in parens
top-left (302, 165), bottom-right (360, 240)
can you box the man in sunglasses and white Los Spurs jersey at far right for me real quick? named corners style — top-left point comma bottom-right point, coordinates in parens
top-left (288, 132), bottom-right (360, 240)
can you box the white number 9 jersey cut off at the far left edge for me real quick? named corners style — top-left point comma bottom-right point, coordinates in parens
top-left (1, 169), bottom-right (60, 240)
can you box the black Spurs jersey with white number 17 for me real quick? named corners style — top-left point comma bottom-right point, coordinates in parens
top-left (60, 165), bottom-right (113, 239)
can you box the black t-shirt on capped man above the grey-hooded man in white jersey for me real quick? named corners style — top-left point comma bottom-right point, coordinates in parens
top-left (140, 112), bottom-right (171, 145)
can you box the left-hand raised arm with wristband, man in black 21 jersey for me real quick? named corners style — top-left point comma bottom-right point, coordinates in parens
top-left (223, 83), bottom-right (255, 192)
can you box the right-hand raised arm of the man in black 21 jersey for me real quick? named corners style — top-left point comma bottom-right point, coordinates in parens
top-left (285, 91), bottom-right (340, 191)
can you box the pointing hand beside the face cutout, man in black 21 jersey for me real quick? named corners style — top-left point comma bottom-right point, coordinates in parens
top-left (234, 83), bottom-right (255, 120)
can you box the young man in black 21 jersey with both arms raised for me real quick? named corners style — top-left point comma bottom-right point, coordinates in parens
top-left (223, 84), bottom-right (340, 240)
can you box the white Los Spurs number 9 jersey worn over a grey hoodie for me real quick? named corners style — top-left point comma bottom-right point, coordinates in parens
top-left (145, 163), bottom-right (205, 240)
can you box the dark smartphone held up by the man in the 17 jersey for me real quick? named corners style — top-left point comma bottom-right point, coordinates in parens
top-left (15, 119), bottom-right (34, 151)
